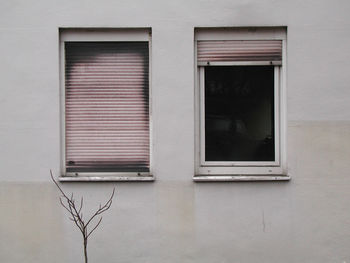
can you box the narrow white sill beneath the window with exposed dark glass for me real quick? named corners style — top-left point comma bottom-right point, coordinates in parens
top-left (193, 174), bottom-right (291, 182)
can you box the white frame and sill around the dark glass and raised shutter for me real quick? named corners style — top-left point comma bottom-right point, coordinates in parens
top-left (193, 27), bottom-right (290, 181)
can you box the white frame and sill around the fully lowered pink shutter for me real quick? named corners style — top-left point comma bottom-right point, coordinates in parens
top-left (59, 28), bottom-right (155, 182)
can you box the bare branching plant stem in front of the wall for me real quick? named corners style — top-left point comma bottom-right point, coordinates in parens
top-left (50, 170), bottom-right (115, 263)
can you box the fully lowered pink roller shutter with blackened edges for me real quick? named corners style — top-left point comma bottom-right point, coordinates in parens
top-left (65, 42), bottom-right (149, 172)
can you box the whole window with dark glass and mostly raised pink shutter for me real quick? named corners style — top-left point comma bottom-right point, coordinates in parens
top-left (194, 28), bottom-right (289, 180)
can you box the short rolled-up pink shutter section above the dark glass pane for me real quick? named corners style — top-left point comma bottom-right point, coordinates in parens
top-left (197, 40), bottom-right (282, 63)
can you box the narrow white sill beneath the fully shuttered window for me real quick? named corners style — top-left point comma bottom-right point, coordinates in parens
top-left (58, 176), bottom-right (155, 182)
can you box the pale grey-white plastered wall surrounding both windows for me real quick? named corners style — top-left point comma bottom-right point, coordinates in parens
top-left (0, 0), bottom-right (350, 263)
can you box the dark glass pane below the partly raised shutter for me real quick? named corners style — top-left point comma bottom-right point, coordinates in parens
top-left (205, 66), bottom-right (275, 161)
